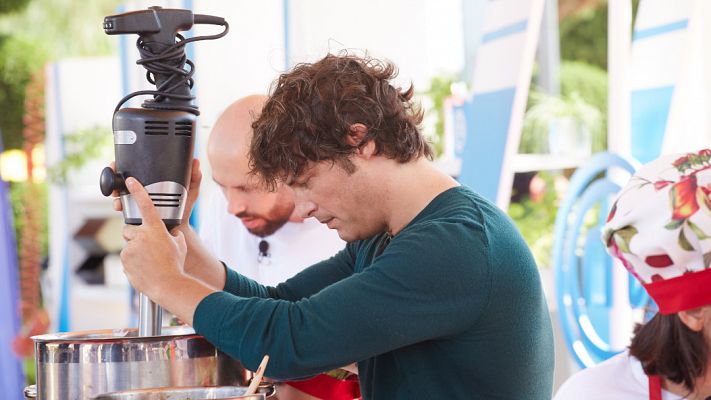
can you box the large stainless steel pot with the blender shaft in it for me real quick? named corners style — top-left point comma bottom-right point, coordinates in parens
top-left (32, 326), bottom-right (250, 400)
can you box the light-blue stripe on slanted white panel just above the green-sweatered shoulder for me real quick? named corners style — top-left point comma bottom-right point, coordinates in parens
top-left (459, 87), bottom-right (516, 203)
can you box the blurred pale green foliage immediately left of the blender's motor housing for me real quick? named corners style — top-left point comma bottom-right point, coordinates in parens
top-left (47, 126), bottom-right (113, 185)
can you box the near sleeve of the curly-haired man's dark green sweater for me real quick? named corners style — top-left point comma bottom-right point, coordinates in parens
top-left (194, 223), bottom-right (491, 379)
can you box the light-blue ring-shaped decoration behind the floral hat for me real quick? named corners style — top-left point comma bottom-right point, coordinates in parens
top-left (553, 153), bottom-right (650, 368)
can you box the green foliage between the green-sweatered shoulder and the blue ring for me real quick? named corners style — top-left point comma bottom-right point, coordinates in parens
top-left (508, 172), bottom-right (558, 268)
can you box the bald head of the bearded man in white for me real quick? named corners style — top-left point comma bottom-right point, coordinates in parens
top-left (207, 95), bottom-right (294, 237)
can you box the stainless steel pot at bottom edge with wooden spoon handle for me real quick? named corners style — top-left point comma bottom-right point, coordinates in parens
top-left (94, 385), bottom-right (274, 400)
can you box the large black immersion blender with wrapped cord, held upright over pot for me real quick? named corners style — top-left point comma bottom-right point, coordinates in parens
top-left (100, 7), bottom-right (229, 336)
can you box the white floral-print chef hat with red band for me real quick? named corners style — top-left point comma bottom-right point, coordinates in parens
top-left (602, 149), bottom-right (711, 314)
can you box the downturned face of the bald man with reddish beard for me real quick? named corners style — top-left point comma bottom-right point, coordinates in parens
top-left (210, 150), bottom-right (294, 237)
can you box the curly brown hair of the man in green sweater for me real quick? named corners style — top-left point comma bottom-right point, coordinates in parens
top-left (250, 54), bottom-right (433, 187)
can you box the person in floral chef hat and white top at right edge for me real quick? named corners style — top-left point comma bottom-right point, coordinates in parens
top-left (555, 149), bottom-right (711, 400)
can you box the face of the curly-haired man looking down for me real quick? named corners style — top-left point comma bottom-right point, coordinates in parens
top-left (288, 161), bottom-right (386, 242)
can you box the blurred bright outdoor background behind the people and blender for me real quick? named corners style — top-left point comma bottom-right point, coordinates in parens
top-left (0, 0), bottom-right (711, 398)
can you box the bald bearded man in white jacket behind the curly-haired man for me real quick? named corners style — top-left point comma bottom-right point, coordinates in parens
top-left (200, 95), bottom-right (357, 400)
